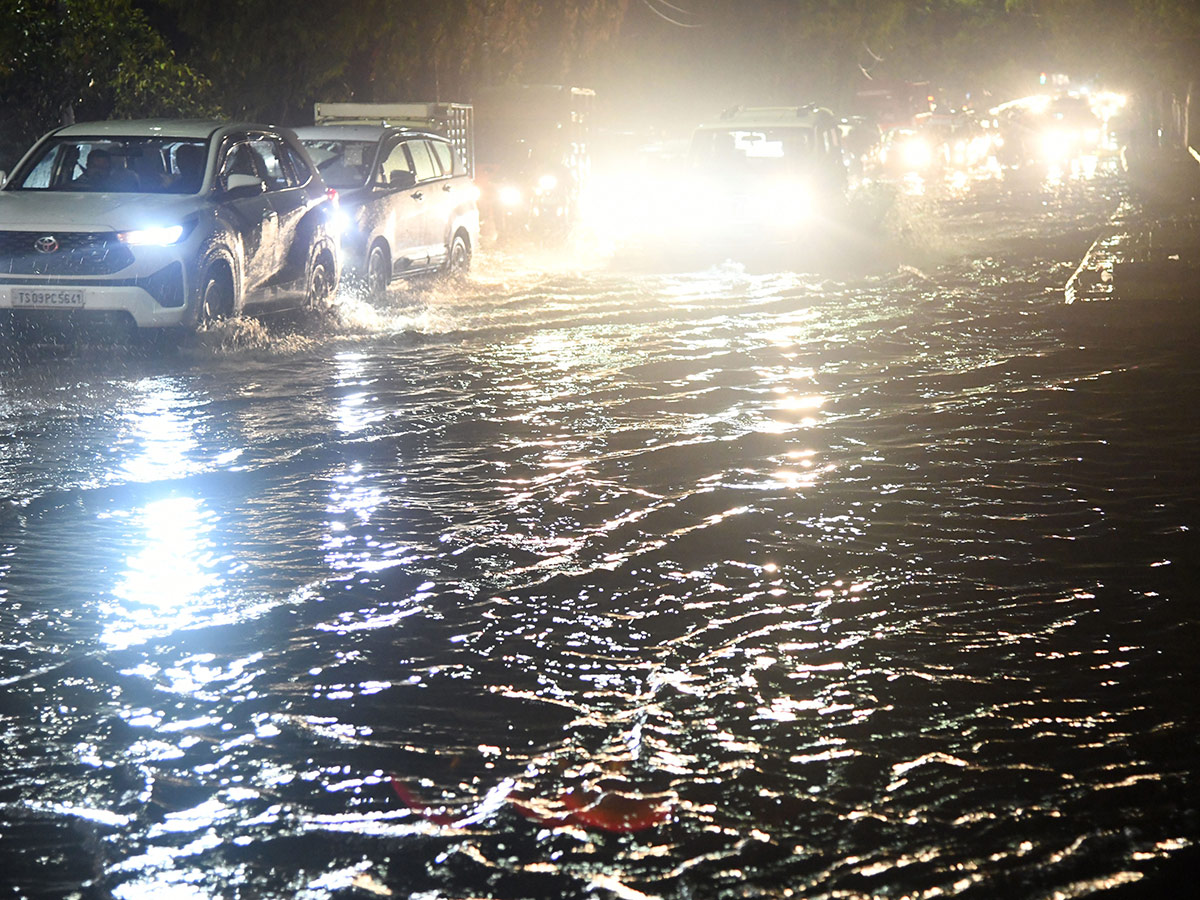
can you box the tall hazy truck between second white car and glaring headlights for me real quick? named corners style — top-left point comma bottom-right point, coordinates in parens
top-left (474, 84), bottom-right (595, 239)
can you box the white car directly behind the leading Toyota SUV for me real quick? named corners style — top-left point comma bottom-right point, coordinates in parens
top-left (296, 125), bottom-right (479, 299)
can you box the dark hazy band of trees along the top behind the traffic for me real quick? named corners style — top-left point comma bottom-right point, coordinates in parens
top-left (0, 0), bottom-right (1200, 169)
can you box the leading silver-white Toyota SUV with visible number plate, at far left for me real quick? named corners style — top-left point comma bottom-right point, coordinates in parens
top-left (0, 119), bottom-right (340, 329)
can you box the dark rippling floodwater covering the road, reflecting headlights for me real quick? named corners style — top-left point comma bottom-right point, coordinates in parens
top-left (0, 165), bottom-right (1200, 900)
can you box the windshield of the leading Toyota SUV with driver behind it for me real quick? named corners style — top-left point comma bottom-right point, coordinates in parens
top-left (7, 137), bottom-right (209, 193)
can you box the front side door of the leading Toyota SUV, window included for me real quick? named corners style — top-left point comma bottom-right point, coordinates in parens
top-left (217, 136), bottom-right (278, 293)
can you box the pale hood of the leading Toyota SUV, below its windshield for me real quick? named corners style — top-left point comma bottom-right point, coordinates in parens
top-left (0, 191), bottom-right (202, 232)
